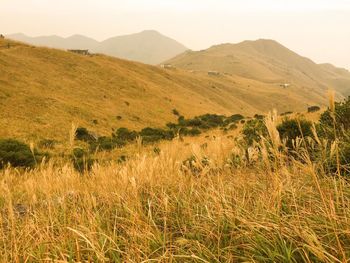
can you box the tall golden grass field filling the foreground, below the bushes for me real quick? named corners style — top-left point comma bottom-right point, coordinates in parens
top-left (0, 110), bottom-right (350, 262)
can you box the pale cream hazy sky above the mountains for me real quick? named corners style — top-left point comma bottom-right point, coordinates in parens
top-left (0, 0), bottom-right (350, 69)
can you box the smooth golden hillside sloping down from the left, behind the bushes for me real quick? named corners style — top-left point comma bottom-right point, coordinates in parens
top-left (0, 39), bottom-right (347, 140)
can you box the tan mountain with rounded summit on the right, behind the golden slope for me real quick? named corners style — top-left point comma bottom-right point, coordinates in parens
top-left (167, 39), bottom-right (350, 98)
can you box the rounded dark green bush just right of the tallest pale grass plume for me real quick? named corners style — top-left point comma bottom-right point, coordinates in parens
top-left (277, 118), bottom-right (312, 149)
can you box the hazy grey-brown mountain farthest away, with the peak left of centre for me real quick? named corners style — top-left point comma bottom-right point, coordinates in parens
top-left (7, 30), bottom-right (187, 65)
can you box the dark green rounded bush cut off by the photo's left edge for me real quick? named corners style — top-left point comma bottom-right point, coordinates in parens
top-left (0, 139), bottom-right (36, 168)
